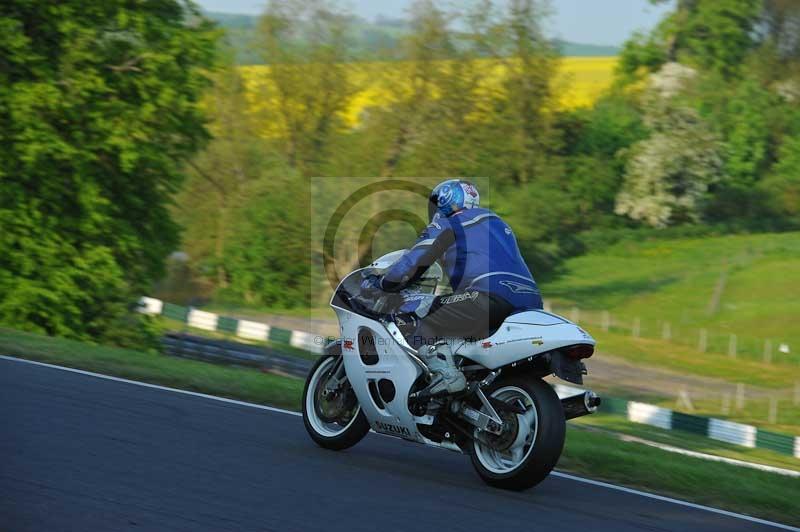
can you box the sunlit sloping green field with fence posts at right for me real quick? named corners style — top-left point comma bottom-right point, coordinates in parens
top-left (542, 232), bottom-right (800, 380)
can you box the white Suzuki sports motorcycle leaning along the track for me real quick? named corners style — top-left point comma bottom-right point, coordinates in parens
top-left (303, 250), bottom-right (600, 490)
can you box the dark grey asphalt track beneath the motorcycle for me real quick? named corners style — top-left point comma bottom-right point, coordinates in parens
top-left (0, 359), bottom-right (796, 532)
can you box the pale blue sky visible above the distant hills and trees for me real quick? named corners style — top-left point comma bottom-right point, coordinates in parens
top-left (195, 0), bottom-right (672, 46)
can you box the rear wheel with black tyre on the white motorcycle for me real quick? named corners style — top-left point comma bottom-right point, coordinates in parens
top-left (470, 375), bottom-right (566, 490)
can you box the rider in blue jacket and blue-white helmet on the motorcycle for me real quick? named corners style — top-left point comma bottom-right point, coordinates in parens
top-left (363, 179), bottom-right (542, 394)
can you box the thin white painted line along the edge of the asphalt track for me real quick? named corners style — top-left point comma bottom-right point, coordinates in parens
top-left (0, 355), bottom-right (800, 532)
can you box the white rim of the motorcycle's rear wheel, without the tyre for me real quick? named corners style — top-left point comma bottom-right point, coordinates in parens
top-left (473, 386), bottom-right (539, 475)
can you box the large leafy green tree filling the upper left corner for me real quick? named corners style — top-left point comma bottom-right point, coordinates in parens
top-left (0, 0), bottom-right (216, 338)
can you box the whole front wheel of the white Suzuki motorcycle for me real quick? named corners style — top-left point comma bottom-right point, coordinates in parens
top-left (303, 355), bottom-right (369, 451)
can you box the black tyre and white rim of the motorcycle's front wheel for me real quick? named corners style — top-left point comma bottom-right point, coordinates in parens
top-left (303, 355), bottom-right (369, 451)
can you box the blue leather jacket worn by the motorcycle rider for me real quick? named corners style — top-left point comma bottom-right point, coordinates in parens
top-left (380, 207), bottom-right (542, 311)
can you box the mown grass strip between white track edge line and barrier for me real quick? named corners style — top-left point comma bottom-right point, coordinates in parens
top-left (0, 328), bottom-right (800, 525)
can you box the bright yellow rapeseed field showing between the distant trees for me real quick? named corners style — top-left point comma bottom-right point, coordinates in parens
top-left (241, 57), bottom-right (617, 132)
